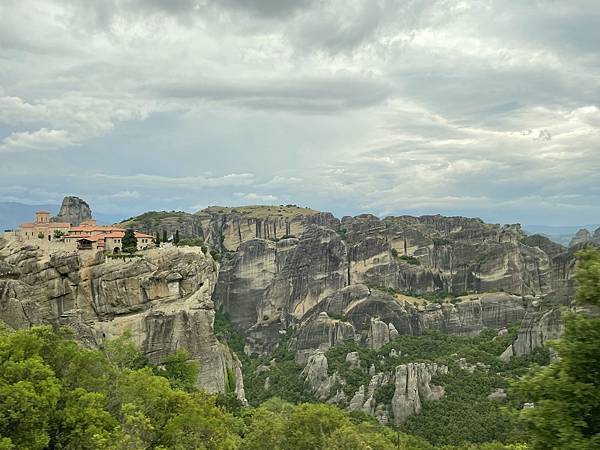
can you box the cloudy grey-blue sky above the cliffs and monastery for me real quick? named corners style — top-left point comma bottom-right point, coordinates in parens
top-left (0, 0), bottom-right (600, 225)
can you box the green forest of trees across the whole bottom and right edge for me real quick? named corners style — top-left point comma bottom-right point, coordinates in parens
top-left (0, 250), bottom-right (600, 450)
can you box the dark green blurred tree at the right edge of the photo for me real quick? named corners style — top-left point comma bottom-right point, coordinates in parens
top-left (514, 250), bottom-right (600, 449)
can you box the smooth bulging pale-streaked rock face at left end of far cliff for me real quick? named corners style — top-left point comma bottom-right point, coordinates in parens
top-left (214, 225), bottom-right (347, 352)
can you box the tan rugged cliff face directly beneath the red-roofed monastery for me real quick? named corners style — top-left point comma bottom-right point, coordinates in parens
top-left (0, 240), bottom-right (244, 399)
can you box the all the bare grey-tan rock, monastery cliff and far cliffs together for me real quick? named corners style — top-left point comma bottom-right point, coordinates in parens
top-left (0, 205), bottom-right (600, 414)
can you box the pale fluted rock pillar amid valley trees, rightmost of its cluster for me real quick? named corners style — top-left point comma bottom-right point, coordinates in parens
top-left (392, 363), bottom-right (448, 425)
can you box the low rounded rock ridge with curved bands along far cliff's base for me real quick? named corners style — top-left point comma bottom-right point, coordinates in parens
top-left (290, 285), bottom-right (528, 356)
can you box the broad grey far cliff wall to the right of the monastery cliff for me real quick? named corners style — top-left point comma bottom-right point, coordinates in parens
top-left (209, 207), bottom-right (575, 361)
